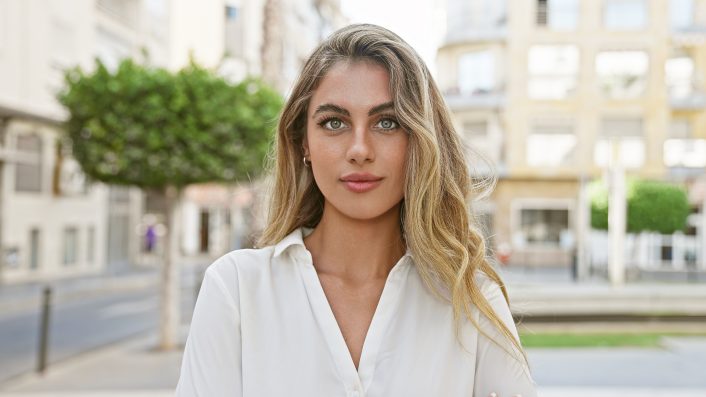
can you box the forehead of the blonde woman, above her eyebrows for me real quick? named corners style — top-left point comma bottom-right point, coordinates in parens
top-left (309, 61), bottom-right (392, 113)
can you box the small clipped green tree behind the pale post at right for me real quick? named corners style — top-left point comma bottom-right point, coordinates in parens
top-left (589, 179), bottom-right (690, 234)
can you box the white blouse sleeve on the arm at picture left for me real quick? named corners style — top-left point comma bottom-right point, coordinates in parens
top-left (176, 262), bottom-right (242, 397)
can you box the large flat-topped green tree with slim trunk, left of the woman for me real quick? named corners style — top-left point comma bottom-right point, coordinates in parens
top-left (58, 59), bottom-right (282, 349)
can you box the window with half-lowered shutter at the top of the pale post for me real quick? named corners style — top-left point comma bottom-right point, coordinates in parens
top-left (593, 117), bottom-right (645, 168)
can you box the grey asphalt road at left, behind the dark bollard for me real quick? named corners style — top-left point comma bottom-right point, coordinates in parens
top-left (0, 277), bottom-right (195, 383)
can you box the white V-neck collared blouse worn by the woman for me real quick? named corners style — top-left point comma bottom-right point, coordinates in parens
top-left (176, 228), bottom-right (536, 397)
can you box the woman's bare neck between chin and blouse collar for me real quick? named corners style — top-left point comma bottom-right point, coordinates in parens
top-left (304, 203), bottom-right (406, 283)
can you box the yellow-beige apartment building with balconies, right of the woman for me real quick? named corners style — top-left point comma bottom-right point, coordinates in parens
top-left (438, 0), bottom-right (706, 266)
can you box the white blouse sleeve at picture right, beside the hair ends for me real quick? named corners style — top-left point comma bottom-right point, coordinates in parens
top-left (473, 277), bottom-right (537, 397)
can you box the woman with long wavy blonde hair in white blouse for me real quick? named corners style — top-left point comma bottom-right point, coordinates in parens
top-left (177, 25), bottom-right (536, 397)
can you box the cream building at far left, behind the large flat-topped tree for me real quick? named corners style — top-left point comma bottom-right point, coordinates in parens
top-left (0, 0), bottom-right (173, 282)
